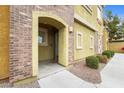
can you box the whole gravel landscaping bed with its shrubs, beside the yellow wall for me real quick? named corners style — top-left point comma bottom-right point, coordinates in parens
top-left (68, 50), bottom-right (114, 84)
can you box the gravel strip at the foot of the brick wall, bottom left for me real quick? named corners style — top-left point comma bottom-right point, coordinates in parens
top-left (0, 81), bottom-right (40, 88)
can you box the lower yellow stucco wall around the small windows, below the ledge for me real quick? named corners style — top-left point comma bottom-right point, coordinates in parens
top-left (74, 21), bottom-right (95, 60)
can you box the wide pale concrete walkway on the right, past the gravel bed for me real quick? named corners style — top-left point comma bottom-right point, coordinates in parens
top-left (99, 53), bottom-right (124, 88)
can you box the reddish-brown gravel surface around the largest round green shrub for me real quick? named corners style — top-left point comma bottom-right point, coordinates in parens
top-left (68, 62), bottom-right (106, 84)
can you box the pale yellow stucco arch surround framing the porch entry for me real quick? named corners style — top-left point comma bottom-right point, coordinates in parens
top-left (32, 11), bottom-right (68, 76)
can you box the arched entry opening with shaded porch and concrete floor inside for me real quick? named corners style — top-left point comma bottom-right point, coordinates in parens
top-left (38, 17), bottom-right (65, 78)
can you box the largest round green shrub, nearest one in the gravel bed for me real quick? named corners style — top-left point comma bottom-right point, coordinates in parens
top-left (86, 56), bottom-right (99, 69)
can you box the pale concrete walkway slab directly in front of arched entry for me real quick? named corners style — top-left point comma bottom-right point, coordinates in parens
top-left (38, 70), bottom-right (95, 88)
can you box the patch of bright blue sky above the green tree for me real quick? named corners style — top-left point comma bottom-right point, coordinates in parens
top-left (104, 5), bottom-right (124, 19)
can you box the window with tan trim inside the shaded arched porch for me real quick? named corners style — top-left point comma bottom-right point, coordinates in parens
top-left (38, 28), bottom-right (48, 46)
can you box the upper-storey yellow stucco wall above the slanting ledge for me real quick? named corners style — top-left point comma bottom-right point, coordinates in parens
top-left (74, 5), bottom-right (103, 32)
